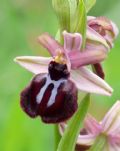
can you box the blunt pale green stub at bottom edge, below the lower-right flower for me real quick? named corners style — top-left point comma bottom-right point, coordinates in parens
top-left (89, 135), bottom-right (106, 151)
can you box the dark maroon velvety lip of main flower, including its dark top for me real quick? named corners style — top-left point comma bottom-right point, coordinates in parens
top-left (21, 61), bottom-right (77, 123)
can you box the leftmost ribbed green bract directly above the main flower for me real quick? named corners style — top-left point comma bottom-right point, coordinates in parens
top-left (52, 0), bottom-right (70, 31)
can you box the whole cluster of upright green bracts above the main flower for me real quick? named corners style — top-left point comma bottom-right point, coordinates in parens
top-left (52, 0), bottom-right (86, 47)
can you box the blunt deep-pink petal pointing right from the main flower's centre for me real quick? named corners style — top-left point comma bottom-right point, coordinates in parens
top-left (69, 49), bottom-right (107, 69)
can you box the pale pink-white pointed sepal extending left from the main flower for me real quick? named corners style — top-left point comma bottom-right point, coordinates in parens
top-left (14, 56), bottom-right (52, 74)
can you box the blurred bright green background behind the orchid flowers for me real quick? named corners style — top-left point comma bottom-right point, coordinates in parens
top-left (0, 0), bottom-right (120, 151)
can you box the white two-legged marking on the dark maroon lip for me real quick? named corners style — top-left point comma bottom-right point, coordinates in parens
top-left (36, 76), bottom-right (66, 107)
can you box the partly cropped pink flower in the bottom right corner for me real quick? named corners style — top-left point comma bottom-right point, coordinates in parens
top-left (59, 101), bottom-right (120, 151)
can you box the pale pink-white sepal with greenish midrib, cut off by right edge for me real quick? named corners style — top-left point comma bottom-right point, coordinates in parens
top-left (102, 101), bottom-right (120, 135)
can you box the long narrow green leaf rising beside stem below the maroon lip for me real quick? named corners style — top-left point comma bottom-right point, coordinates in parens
top-left (57, 94), bottom-right (90, 151)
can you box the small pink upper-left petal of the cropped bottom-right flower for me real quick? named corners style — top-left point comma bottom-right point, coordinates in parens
top-left (84, 115), bottom-right (102, 136)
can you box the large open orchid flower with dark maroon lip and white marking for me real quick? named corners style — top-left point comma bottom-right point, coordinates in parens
top-left (15, 31), bottom-right (112, 123)
